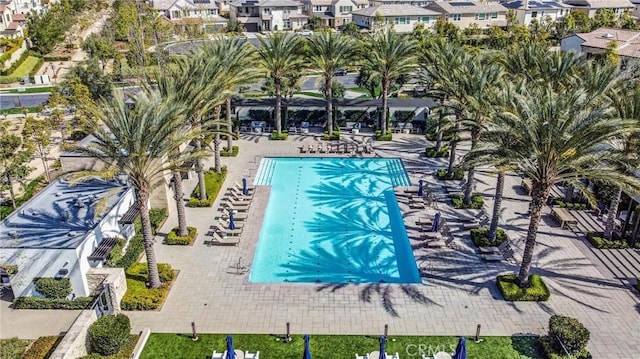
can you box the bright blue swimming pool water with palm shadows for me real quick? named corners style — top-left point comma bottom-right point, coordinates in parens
top-left (249, 158), bottom-right (421, 283)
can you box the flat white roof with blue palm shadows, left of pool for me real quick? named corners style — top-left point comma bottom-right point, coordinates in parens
top-left (0, 179), bottom-right (129, 249)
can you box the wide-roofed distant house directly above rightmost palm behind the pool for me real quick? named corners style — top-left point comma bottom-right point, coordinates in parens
top-left (351, 5), bottom-right (440, 33)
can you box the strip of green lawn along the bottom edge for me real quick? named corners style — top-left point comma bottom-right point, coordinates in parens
top-left (140, 334), bottom-right (544, 359)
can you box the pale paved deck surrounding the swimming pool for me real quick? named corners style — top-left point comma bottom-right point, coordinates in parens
top-left (0, 135), bottom-right (640, 358)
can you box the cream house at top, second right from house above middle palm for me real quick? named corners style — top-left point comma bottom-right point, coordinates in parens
top-left (427, 1), bottom-right (507, 29)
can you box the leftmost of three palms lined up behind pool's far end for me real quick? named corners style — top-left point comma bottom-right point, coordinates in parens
top-left (257, 32), bottom-right (304, 135)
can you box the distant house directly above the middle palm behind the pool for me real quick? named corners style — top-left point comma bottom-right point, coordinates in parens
top-left (302, 0), bottom-right (369, 29)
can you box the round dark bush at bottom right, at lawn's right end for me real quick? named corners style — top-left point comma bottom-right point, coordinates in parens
top-left (547, 315), bottom-right (590, 355)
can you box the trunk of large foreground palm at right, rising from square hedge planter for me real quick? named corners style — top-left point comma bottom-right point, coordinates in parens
top-left (518, 182), bottom-right (551, 288)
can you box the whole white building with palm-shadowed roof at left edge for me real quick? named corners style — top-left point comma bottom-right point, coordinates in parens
top-left (0, 179), bottom-right (138, 297)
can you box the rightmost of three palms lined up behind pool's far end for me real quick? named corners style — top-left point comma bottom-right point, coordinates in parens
top-left (362, 27), bottom-right (417, 133)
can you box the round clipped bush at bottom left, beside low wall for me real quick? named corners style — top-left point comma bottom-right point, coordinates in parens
top-left (89, 314), bottom-right (131, 355)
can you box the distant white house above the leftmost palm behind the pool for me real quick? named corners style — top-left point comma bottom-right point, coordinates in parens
top-left (229, 0), bottom-right (309, 32)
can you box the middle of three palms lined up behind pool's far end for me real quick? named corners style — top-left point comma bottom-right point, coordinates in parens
top-left (307, 31), bottom-right (356, 134)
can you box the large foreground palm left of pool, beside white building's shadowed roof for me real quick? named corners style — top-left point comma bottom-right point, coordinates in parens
top-left (75, 92), bottom-right (205, 288)
